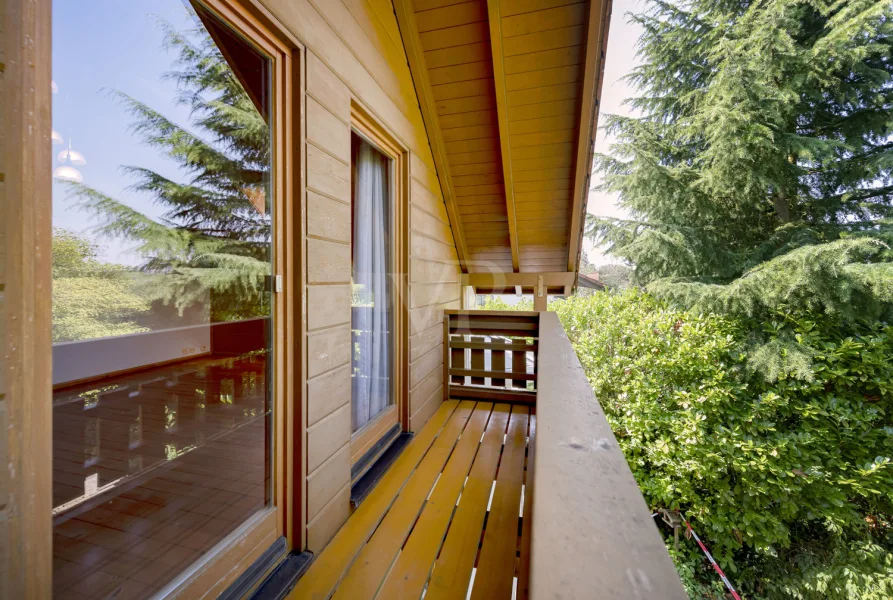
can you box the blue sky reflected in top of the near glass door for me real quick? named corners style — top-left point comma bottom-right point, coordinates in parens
top-left (53, 0), bottom-right (194, 265)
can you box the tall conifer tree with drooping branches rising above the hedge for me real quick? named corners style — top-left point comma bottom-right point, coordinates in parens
top-left (587, 0), bottom-right (893, 321)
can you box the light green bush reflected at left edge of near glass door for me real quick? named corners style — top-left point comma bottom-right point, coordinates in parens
top-left (53, 229), bottom-right (149, 342)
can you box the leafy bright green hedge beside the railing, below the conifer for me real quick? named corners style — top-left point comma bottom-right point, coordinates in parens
top-left (552, 290), bottom-right (893, 600)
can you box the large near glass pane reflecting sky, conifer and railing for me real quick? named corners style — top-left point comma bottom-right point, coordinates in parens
top-left (52, 0), bottom-right (272, 599)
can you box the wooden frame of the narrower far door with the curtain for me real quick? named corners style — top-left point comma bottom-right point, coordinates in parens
top-left (350, 99), bottom-right (409, 468)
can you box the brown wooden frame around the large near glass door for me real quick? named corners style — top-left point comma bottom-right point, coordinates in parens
top-left (0, 0), bottom-right (306, 598)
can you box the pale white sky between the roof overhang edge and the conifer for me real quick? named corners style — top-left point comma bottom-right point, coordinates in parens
top-left (583, 0), bottom-right (643, 265)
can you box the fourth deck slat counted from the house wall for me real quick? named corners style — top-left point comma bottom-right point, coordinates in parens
top-left (425, 404), bottom-right (511, 600)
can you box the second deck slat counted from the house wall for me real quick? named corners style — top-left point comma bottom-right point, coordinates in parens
top-left (334, 401), bottom-right (487, 600)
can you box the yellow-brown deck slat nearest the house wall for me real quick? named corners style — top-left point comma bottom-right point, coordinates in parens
top-left (288, 400), bottom-right (459, 600)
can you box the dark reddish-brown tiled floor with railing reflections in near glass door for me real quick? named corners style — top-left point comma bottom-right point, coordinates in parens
top-left (53, 356), bottom-right (268, 600)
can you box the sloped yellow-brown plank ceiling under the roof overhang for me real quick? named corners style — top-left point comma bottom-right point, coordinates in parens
top-left (394, 0), bottom-right (610, 273)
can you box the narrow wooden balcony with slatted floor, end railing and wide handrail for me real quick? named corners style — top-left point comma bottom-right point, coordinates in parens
top-left (289, 311), bottom-right (687, 600)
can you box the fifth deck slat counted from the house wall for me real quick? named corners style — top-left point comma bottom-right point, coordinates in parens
top-left (471, 406), bottom-right (530, 600)
